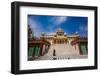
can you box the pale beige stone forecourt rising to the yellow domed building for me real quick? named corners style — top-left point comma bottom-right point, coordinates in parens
top-left (37, 44), bottom-right (87, 60)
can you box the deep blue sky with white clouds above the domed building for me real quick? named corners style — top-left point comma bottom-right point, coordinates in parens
top-left (28, 15), bottom-right (88, 37)
